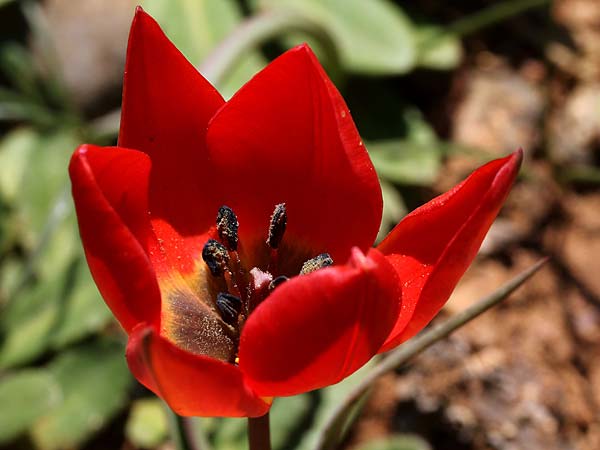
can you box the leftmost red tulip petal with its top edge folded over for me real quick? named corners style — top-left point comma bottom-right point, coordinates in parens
top-left (69, 145), bottom-right (160, 331)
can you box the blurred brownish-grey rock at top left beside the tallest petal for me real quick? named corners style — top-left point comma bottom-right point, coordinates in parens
top-left (38, 0), bottom-right (137, 108)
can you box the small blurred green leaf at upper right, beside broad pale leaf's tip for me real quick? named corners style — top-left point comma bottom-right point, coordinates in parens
top-left (416, 24), bottom-right (462, 70)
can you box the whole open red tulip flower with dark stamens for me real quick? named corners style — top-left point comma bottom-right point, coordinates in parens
top-left (69, 9), bottom-right (521, 417)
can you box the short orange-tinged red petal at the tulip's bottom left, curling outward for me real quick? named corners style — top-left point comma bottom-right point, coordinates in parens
top-left (126, 326), bottom-right (271, 417)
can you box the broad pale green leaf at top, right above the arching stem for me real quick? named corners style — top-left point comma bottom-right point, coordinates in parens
top-left (258, 0), bottom-right (417, 75)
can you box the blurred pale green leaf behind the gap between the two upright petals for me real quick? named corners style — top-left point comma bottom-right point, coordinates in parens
top-left (141, 0), bottom-right (266, 98)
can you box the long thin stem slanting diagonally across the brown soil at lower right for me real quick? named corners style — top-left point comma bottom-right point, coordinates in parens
top-left (315, 258), bottom-right (548, 450)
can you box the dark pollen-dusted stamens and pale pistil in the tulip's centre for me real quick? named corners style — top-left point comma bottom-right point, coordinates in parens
top-left (202, 203), bottom-right (333, 339)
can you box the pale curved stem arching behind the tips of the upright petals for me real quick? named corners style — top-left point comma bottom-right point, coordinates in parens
top-left (200, 10), bottom-right (337, 86)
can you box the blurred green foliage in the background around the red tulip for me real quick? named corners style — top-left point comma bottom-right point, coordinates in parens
top-left (0, 0), bottom-right (543, 450)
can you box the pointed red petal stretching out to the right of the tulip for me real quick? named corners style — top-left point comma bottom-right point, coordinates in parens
top-left (378, 150), bottom-right (522, 351)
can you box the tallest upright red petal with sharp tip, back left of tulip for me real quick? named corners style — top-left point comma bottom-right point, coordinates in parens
top-left (119, 8), bottom-right (224, 278)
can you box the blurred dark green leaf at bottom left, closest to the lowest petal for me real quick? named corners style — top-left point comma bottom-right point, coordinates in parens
top-left (32, 340), bottom-right (132, 450)
